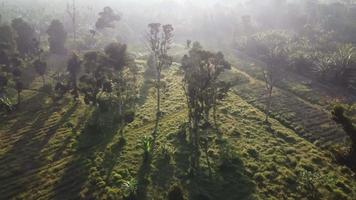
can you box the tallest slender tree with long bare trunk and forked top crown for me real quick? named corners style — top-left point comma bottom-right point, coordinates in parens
top-left (147, 23), bottom-right (174, 138)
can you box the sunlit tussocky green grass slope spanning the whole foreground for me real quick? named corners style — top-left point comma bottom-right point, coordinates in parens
top-left (0, 62), bottom-right (356, 199)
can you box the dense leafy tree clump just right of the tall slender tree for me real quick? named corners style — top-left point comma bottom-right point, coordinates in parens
top-left (181, 43), bottom-right (231, 168)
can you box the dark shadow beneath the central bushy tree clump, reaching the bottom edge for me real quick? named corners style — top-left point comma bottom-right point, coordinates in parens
top-left (169, 123), bottom-right (256, 200)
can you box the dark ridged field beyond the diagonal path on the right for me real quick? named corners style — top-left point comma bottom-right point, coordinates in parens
top-left (225, 53), bottom-right (347, 147)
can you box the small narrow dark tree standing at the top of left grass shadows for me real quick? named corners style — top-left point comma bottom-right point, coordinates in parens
top-left (67, 53), bottom-right (82, 99)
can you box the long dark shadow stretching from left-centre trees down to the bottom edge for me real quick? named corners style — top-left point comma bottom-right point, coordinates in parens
top-left (54, 109), bottom-right (125, 200)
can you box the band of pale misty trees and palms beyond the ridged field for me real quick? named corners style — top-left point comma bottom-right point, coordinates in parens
top-left (239, 31), bottom-right (356, 91)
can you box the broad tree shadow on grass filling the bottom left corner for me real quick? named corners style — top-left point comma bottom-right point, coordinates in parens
top-left (0, 101), bottom-right (77, 199)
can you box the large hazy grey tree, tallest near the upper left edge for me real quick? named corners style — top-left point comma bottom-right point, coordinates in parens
top-left (11, 18), bottom-right (36, 56)
